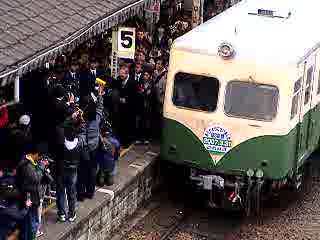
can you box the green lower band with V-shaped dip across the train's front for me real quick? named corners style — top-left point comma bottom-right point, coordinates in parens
top-left (161, 119), bottom-right (298, 179)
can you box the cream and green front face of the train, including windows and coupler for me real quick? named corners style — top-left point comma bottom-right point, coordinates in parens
top-left (161, 43), bottom-right (298, 214)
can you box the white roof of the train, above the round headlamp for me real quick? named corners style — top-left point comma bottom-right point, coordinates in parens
top-left (173, 0), bottom-right (320, 65)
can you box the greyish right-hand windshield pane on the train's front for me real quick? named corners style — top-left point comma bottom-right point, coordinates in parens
top-left (224, 81), bottom-right (279, 121)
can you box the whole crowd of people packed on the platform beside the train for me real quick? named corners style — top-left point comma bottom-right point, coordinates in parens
top-left (0, 15), bottom-right (184, 240)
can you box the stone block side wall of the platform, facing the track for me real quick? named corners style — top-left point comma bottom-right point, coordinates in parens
top-left (59, 156), bottom-right (160, 240)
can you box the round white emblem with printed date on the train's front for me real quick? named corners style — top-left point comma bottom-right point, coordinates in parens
top-left (203, 125), bottom-right (232, 154)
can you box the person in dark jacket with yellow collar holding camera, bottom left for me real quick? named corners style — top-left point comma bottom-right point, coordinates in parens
top-left (16, 144), bottom-right (53, 240)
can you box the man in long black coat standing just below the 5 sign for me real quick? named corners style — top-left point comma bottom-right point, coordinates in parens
top-left (112, 65), bottom-right (137, 147)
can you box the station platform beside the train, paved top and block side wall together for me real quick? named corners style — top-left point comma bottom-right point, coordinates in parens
top-left (29, 145), bottom-right (160, 240)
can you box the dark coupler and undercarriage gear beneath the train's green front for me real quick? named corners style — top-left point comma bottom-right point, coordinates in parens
top-left (162, 164), bottom-right (308, 216)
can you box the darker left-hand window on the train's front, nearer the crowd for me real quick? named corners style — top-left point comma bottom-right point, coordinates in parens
top-left (172, 73), bottom-right (219, 112)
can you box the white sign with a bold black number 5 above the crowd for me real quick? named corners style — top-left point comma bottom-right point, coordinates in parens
top-left (118, 28), bottom-right (136, 59)
